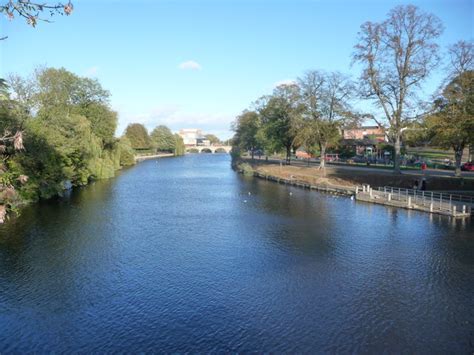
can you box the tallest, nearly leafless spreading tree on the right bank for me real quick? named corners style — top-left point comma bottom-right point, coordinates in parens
top-left (353, 5), bottom-right (443, 173)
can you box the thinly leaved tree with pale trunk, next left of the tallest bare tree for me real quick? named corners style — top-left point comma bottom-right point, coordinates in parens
top-left (297, 71), bottom-right (355, 169)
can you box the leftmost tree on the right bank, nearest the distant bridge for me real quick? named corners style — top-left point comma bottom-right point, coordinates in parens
top-left (233, 111), bottom-right (261, 159)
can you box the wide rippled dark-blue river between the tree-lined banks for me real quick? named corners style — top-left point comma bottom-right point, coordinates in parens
top-left (0, 154), bottom-right (474, 354)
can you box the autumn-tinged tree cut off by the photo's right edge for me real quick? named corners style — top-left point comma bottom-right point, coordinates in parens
top-left (426, 41), bottom-right (474, 176)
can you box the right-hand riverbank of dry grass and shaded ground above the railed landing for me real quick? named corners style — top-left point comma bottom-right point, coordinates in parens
top-left (233, 158), bottom-right (474, 193)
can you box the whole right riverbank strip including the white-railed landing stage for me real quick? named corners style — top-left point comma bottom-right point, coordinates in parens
top-left (233, 159), bottom-right (474, 218)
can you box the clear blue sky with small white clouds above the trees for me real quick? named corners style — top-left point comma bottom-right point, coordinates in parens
top-left (0, 0), bottom-right (474, 138)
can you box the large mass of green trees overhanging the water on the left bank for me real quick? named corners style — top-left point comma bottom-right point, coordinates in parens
top-left (0, 69), bottom-right (136, 221)
